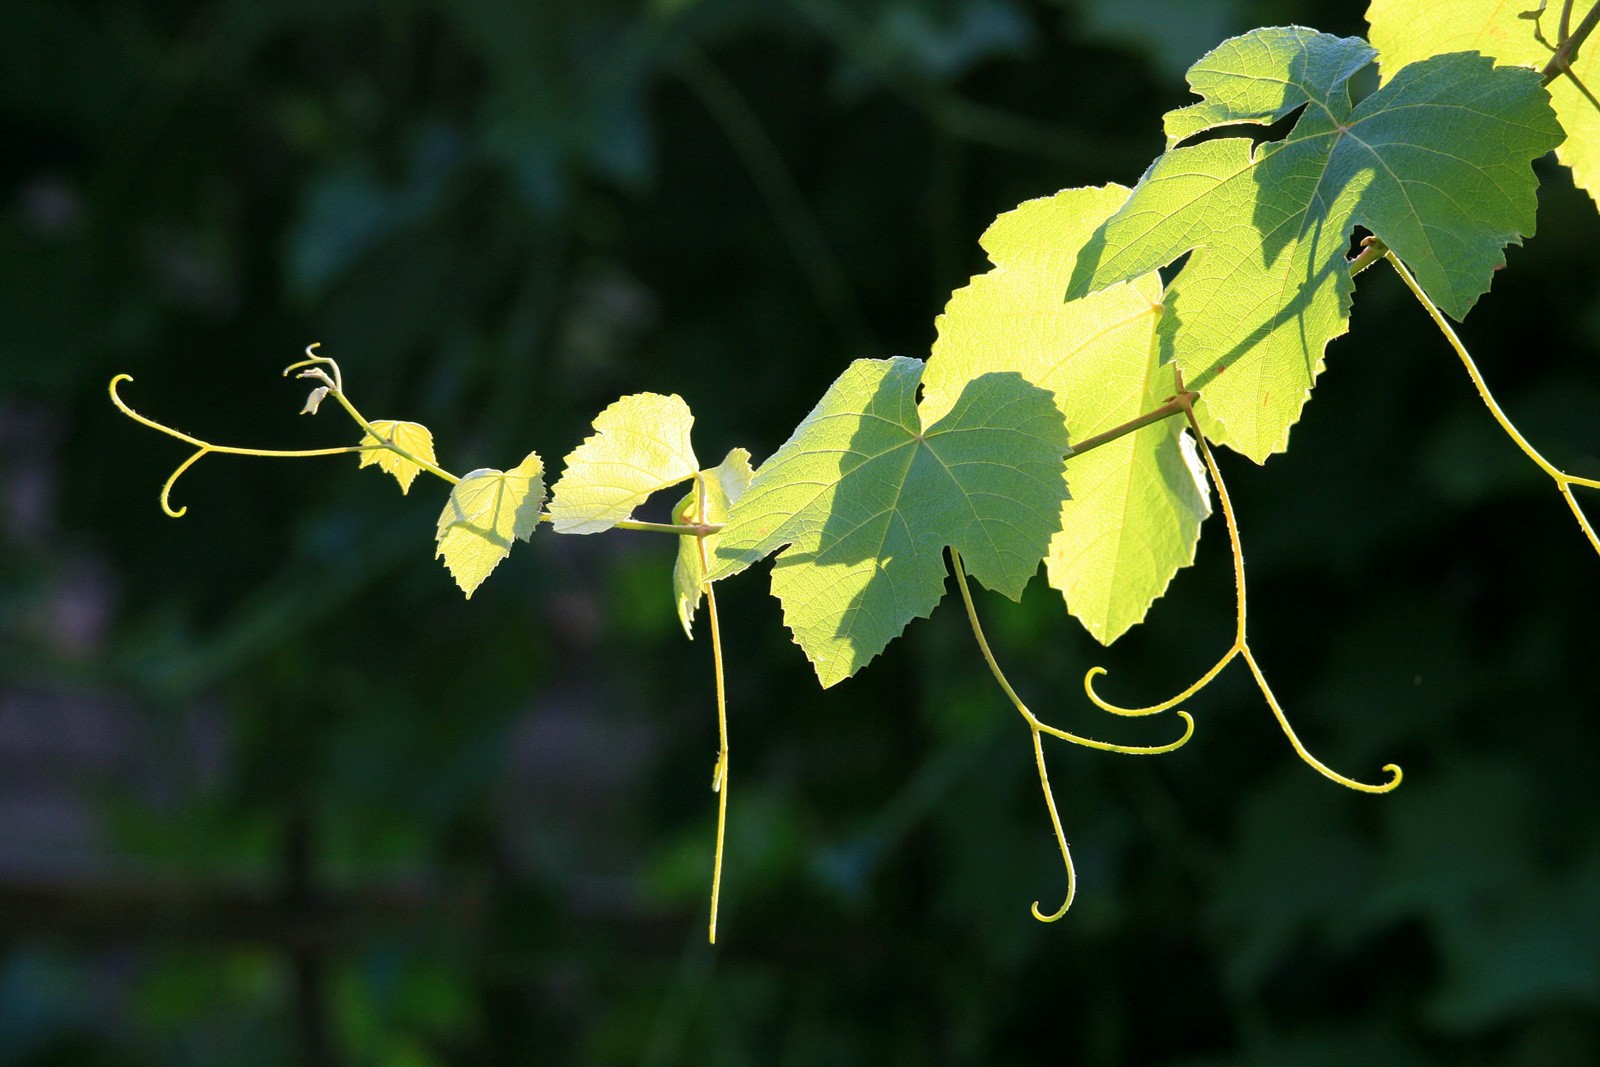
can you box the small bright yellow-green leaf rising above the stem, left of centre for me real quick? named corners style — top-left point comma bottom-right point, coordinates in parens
top-left (550, 392), bottom-right (699, 534)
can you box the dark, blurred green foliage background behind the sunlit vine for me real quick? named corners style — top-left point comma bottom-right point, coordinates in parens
top-left (0, 0), bottom-right (1600, 1067)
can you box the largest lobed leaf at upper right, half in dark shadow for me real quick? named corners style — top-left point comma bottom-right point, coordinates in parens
top-left (1067, 27), bottom-right (1562, 462)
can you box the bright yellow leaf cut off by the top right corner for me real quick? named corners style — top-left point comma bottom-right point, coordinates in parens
top-left (1366, 0), bottom-right (1600, 211)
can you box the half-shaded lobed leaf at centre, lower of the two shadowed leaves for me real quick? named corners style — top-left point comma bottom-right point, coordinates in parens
top-left (709, 357), bottom-right (1067, 686)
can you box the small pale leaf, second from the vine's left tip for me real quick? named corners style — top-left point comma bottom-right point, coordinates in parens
top-left (435, 453), bottom-right (544, 598)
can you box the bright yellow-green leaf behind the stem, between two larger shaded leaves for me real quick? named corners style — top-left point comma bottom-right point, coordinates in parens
top-left (922, 186), bottom-right (1211, 645)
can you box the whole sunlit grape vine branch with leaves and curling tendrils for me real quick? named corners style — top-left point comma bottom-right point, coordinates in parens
top-left (110, 8), bottom-right (1600, 941)
